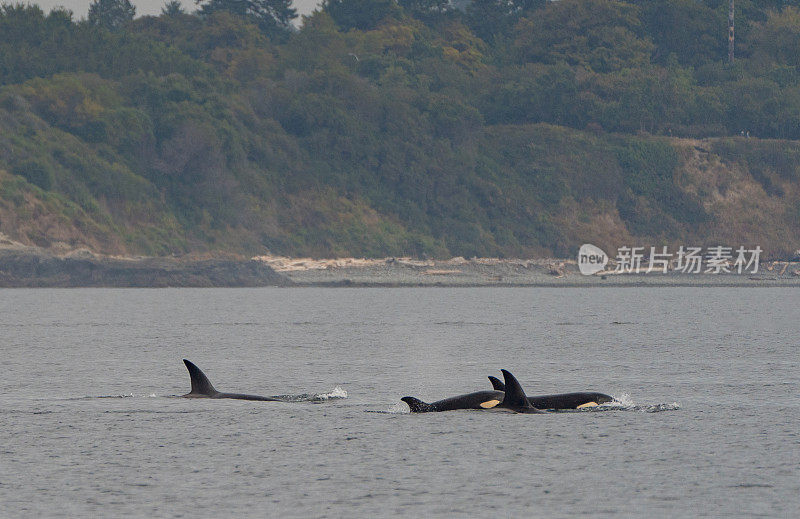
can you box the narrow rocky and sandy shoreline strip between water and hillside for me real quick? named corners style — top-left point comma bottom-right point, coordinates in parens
top-left (0, 239), bottom-right (800, 288)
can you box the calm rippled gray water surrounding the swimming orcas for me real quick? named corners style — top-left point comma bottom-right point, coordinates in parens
top-left (0, 288), bottom-right (800, 517)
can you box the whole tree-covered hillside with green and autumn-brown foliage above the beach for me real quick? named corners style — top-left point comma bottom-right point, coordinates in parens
top-left (0, 0), bottom-right (800, 257)
